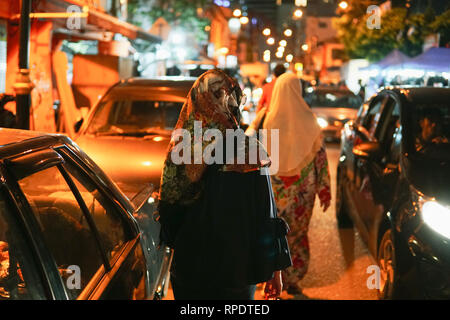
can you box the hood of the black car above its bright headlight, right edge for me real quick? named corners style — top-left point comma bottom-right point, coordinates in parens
top-left (405, 156), bottom-right (450, 204)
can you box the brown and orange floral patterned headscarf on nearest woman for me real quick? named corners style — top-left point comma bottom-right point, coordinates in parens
top-left (160, 69), bottom-right (270, 205)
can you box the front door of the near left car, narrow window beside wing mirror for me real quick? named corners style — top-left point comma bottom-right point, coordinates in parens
top-left (54, 148), bottom-right (150, 300)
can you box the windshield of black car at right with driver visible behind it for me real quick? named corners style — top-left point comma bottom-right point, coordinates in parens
top-left (411, 104), bottom-right (450, 159)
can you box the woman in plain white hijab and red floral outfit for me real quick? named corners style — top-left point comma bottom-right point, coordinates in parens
top-left (263, 73), bottom-right (331, 294)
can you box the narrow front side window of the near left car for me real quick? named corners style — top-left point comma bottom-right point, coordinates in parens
top-left (60, 163), bottom-right (129, 263)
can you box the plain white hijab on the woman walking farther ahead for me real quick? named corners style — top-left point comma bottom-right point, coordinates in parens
top-left (263, 73), bottom-right (322, 176)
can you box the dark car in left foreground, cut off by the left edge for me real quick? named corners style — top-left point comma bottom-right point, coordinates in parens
top-left (0, 129), bottom-right (170, 300)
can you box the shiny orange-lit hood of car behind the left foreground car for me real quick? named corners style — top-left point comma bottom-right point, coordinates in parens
top-left (76, 135), bottom-right (170, 199)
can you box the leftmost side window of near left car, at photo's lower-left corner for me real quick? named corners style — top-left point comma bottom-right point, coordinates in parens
top-left (0, 190), bottom-right (46, 300)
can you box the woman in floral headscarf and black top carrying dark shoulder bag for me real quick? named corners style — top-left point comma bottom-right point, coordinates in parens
top-left (158, 69), bottom-right (291, 300)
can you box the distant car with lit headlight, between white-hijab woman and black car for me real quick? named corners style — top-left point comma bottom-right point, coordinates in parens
top-left (305, 86), bottom-right (363, 141)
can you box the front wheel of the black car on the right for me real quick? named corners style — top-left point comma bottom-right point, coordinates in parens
top-left (377, 229), bottom-right (398, 300)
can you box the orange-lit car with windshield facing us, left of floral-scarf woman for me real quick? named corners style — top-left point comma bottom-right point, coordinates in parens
top-left (75, 77), bottom-right (195, 192)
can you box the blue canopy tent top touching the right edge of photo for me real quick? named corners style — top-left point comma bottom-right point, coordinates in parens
top-left (403, 48), bottom-right (450, 73)
